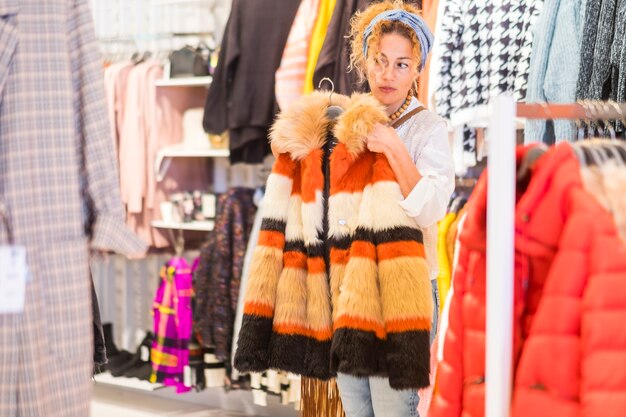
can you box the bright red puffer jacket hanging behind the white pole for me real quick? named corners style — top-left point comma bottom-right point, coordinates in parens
top-left (430, 144), bottom-right (626, 417)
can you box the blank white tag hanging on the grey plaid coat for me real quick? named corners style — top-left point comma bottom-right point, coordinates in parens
top-left (0, 246), bottom-right (28, 314)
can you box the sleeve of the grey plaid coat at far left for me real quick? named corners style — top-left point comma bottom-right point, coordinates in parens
top-left (69, 0), bottom-right (147, 256)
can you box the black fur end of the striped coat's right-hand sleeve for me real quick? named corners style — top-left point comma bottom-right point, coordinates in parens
top-left (385, 330), bottom-right (430, 389)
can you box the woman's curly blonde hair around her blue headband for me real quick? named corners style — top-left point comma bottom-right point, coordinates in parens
top-left (349, 0), bottom-right (422, 83)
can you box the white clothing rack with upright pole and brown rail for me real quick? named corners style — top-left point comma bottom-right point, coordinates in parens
top-left (453, 95), bottom-right (626, 417)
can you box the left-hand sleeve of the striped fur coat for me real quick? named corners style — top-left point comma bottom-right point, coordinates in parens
top-left (234, 154), bottom-right (295, 372)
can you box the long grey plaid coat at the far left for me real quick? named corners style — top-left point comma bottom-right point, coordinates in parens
top-left (0, 0), bottom-right (145, 417)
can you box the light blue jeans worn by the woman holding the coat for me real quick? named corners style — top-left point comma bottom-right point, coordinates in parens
top-left (337, 280), bottom-right (439, 417)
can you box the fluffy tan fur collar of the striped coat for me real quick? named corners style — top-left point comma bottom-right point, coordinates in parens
top-left (270, 91), bottom-right (387, 160)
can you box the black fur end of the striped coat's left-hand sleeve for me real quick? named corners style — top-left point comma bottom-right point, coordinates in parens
top-left (235, 314), bottom-right (272, 372)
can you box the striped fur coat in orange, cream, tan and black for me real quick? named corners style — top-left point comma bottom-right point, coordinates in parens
top-left (235, 93), bottom-right (433, 389)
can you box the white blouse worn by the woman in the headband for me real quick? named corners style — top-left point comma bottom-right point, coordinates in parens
top-left (396, 98), bottom-right (454, 279)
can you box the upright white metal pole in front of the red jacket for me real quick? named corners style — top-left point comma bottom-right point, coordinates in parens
top-left (485, 96), bottom-right (516, 417)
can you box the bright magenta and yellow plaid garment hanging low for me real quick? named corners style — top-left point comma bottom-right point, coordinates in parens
top-left (150, 258), bottom-right (193, 393)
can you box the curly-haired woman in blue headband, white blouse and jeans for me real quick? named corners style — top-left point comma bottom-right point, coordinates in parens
top-left (337, 1), bottom-right (454, 417)
